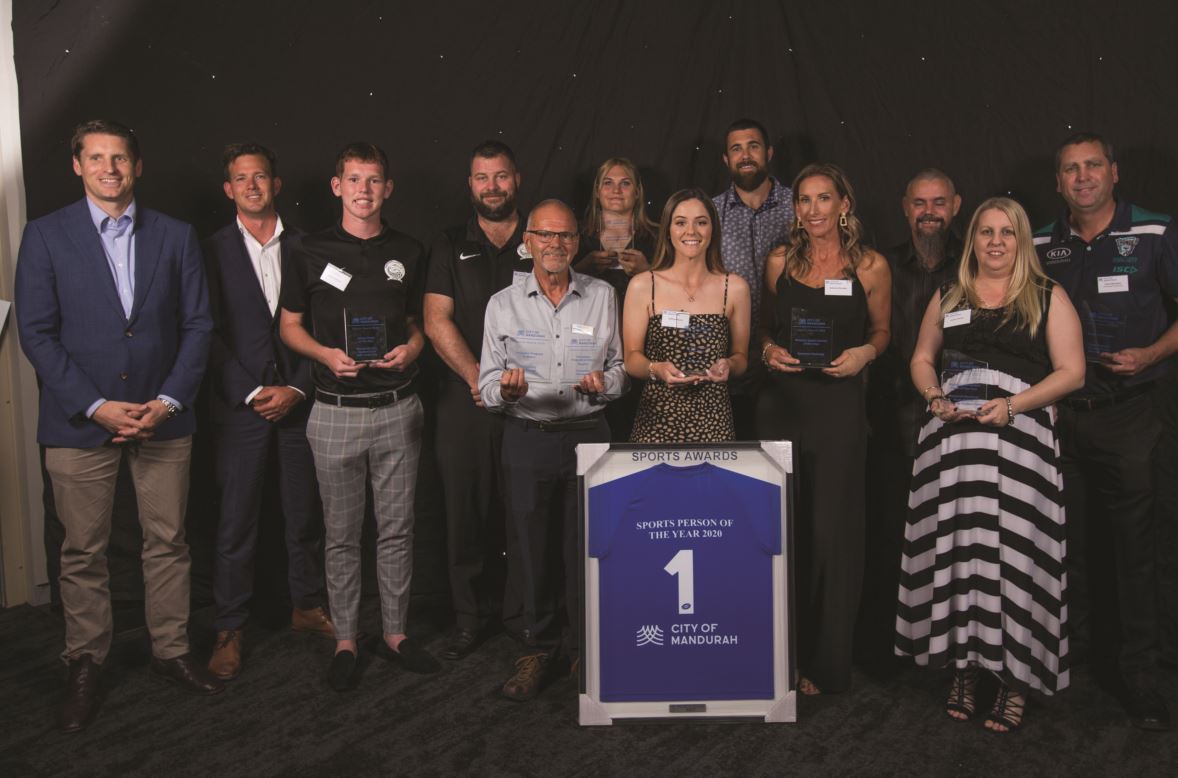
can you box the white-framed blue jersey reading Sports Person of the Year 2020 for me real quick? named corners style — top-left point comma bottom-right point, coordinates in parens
top-left (577, 441), bottom-right (796, 725)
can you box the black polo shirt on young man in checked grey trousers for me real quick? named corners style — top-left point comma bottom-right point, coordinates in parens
top-left (282, 224), bottom-right (425, 395)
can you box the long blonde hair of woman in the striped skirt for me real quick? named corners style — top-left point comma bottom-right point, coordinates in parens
top-left (941, 197), bottom-right (1051, 337)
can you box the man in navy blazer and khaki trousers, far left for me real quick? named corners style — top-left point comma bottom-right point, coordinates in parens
top-left (15, 120), bottom-right (223, 732)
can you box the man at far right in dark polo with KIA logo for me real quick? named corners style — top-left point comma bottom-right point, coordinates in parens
top-left (1034, 133), bottom-right (1178, 730)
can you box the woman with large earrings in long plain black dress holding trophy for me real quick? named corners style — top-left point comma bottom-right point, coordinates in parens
top-left (757, 164), bottom-right (892, 694)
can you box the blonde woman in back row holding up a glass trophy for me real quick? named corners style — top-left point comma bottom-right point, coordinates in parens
top-left (573, 157), bottom-right (659, 441)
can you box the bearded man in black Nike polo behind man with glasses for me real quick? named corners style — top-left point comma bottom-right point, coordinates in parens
top-left (424, 140), bottom-right (532, 659)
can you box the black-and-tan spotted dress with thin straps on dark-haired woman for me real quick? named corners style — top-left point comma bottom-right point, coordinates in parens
top-left (630, 271), bottom-right (736, 443)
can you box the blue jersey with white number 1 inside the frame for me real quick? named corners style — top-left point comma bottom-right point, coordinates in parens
top-left (588, 463), bottom-right (781, 701)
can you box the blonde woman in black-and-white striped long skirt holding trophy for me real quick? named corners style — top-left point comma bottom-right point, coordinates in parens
top-left (896, 197), bottom-right (1085, 732)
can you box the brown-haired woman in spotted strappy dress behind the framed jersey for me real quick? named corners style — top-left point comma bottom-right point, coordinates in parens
top-left (622, 189), bottom-right (752, 443)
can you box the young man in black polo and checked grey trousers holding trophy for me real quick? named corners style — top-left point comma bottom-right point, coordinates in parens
top-left (282, 143), bottom-right (438, 691)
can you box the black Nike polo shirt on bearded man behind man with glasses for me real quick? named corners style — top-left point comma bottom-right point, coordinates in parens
top-left (425, 213), bottom-right (532, 383)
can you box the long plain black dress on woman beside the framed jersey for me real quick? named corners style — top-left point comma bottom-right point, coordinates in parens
top-left (757, 272), bottom-right (867, 693)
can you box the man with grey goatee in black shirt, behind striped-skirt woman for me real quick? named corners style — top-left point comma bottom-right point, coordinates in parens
top-left (855, 167), bottom-right (961, 664)
